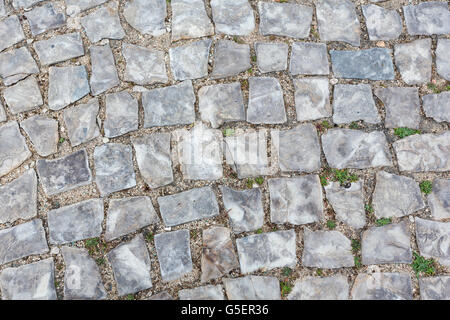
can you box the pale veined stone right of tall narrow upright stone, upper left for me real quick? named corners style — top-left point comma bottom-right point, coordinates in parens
top-left (122, 43), bottom-right (168, 85)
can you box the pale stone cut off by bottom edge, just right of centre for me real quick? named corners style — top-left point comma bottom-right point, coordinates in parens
top-left (222, 276), bottom-right (281, 300)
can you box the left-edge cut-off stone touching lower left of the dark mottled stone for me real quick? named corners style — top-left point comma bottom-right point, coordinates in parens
top-left (0, 169), bottom-right (37, 223)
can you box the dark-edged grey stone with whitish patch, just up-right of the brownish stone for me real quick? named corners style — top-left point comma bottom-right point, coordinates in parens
top-left (220, 186), bottom-right (264, 233)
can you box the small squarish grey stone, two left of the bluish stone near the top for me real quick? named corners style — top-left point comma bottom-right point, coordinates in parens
top-left (255, 42), bottom-right (289, 73)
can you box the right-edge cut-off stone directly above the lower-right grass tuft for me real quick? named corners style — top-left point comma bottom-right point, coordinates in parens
top-left (416, 218), bottom-right (450, 267)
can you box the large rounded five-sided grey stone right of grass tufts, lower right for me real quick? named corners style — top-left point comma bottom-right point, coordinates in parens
top-left (372, 171), bottom-right (425, 218)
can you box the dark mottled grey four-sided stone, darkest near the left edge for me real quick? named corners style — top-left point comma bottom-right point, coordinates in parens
top-left (36, 149), bottom-right (92, 195)
